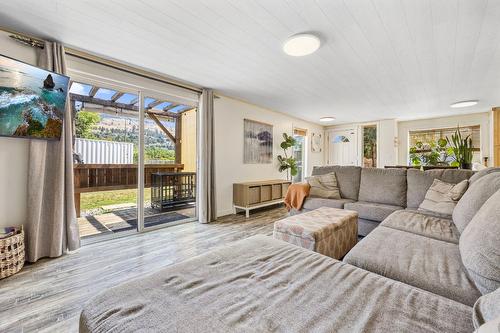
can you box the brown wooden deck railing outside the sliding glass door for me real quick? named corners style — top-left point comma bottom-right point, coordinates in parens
top-left (73, 163), bottom-right (184, 216)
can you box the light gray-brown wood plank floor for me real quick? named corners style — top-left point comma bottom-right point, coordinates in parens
top-left (0, 207), bottom-right (286, 332)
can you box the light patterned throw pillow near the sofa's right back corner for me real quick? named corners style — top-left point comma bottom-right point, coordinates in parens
top-left (418, 179), bottom-right (469, 216)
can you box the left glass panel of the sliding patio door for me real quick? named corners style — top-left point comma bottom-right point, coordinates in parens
top-left (70, 82), bottom-right (139, 240)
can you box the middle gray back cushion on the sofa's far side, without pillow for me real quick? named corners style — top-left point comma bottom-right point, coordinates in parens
top-left (359, 168), bottom-right (406, 207)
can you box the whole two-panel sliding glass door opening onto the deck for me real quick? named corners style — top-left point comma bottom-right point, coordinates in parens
top-left (71, 77), bottom-right (197, 243)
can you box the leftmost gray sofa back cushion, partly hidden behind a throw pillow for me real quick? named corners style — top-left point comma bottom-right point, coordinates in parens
top-left (312, 165), bottom-right (361, 200)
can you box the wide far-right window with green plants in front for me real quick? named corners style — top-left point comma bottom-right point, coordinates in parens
top-left (408, 125), bottom-right (481, 165)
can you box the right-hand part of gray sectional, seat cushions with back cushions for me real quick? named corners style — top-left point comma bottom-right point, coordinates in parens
top-left (344, 172), bottom-right (500, 308)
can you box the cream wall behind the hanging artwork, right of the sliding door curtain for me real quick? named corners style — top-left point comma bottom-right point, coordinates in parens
top-left (214, 96), bottom-right (324, 216)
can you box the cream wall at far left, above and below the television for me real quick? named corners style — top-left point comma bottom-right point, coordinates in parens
top-left (0, 31), bottom-right (36, 227)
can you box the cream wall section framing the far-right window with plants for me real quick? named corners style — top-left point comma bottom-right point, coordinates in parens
top-left (398, 112), bottom-right (493, 165)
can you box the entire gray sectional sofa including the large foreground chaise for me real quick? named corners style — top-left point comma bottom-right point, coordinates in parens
top-left (80, 167), bottom-right (500, 333)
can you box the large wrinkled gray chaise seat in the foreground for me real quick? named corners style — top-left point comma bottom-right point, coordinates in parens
top-left (80, 236), bottom-right (473, 332)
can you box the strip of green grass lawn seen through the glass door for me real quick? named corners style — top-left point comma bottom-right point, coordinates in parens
top-left (80, 188), bottom-right (151, 211)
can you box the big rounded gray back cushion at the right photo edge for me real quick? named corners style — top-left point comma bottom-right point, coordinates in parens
top-left (459, 188), bottom-right (500, 294)
